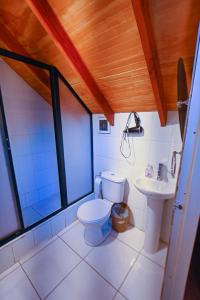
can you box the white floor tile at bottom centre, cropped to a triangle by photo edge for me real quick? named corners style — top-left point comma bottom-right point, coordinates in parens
top-left (47, 261), bottom-right (116, 300)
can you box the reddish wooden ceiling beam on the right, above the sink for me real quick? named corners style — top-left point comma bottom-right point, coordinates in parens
top-left (132, 0), bottom-right (167, 126)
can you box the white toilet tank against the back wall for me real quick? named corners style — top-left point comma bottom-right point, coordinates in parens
top-left (101, 171), bottom-right (126, 203)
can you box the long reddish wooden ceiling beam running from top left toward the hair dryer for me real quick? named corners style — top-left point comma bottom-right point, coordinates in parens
top-left (26, 0), bottom-right (114, 125)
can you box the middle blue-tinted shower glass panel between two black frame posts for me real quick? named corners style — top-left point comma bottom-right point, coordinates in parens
top-left (0, 58), bottom-right (61, 227)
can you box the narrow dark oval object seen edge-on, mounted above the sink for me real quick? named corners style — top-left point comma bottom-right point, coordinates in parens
top-left (177, 58), bottom-right (188, 140)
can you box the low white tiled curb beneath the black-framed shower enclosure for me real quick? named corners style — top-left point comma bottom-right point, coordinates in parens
top-left (0, 194), bottom-right (94, 273)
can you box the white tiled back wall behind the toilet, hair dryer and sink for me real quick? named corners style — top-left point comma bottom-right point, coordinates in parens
top-left (93, 112), bottom-right (182, 241)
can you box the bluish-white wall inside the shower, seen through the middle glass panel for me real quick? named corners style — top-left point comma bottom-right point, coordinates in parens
top-left (0, 61), bottom-right (59, 208)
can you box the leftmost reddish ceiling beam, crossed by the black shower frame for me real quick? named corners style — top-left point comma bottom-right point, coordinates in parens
top-left (0, 24), bottom-right (50, 89)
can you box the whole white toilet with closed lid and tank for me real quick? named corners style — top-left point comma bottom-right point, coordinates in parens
top-left (77, 171), bottom-right (126, 246)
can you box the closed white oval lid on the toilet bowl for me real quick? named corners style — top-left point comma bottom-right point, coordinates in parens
top-left (77, 199), bottom-right (112, 223)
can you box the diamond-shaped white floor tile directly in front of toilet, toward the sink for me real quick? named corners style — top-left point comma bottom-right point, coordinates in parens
top-left (85, 237), bottom-right (138, 289)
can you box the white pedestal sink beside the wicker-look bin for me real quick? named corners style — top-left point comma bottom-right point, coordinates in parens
top-left (135, 177), bottom-right (175, 253)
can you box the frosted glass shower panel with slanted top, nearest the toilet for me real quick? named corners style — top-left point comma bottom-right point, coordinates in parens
top-left (59, 79), bottom-right (93, 204)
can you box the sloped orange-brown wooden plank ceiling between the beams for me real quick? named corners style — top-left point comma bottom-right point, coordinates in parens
top-left (0, 0), bottom-right (200, 121)
